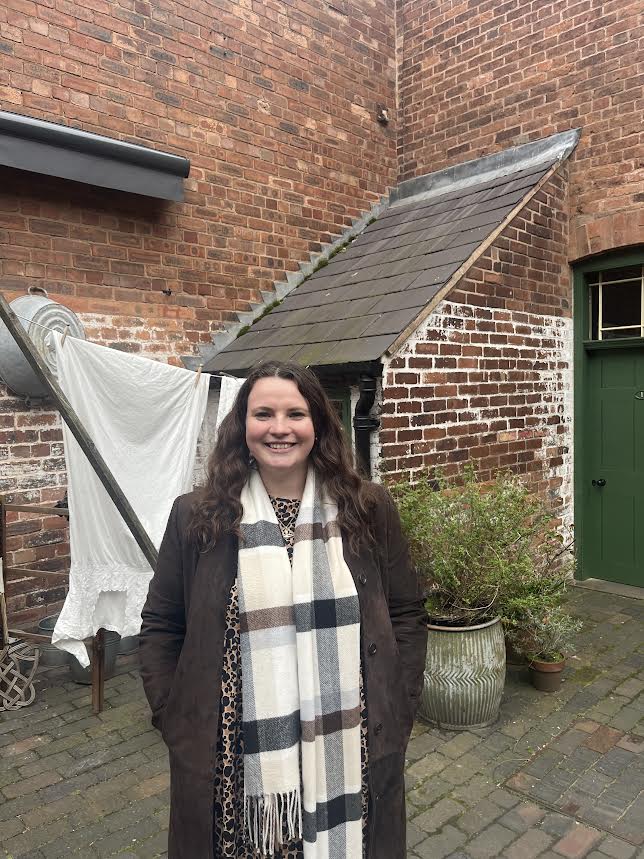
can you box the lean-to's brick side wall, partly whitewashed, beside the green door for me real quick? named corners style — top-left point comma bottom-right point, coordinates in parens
top-left (380, 167), bottom-right (572, 516)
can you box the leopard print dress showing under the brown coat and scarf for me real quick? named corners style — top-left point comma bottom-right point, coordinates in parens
top-left (214, 497), bottom-right (369, 859)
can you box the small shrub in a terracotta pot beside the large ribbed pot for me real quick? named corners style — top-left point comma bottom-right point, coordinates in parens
top-left (517, 606), bottom-right (583, 692)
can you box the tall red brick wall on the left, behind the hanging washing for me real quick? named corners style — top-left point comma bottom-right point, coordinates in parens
top-left (0, 0), bottom-right (396, 624)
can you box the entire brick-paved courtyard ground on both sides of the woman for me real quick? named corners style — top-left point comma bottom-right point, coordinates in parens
top-left (0, 589), bottom-right (644, 859)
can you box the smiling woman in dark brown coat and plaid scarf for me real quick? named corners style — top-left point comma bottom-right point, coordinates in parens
top-left (140, 362), bottom-right (427, 859)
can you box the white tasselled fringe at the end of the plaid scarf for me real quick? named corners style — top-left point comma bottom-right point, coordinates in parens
top-left (244, 788), bottom-right (302, 856)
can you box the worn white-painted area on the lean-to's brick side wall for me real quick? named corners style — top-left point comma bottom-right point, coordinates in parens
top-left (378, 301), bottom-right (573, 524)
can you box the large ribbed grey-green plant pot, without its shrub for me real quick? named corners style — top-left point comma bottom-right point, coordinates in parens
top-left (418, 617), bottom-right (505, 731)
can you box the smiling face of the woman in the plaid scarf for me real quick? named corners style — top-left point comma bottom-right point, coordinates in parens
top-left (246, 377), bottom-right (315, 477)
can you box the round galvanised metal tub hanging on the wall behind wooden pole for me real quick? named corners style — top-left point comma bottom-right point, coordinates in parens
top-left (0, 287), bottom-right (85, 398)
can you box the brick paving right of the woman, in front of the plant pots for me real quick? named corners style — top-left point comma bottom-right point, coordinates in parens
top-left (407, 589), bottom-right (644, 859)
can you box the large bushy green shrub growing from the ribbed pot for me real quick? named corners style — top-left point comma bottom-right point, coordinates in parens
top-left (390, 467), bottom-right (573, 638)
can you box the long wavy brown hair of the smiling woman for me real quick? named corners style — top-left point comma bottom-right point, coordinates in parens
top-left (190, 361), bottom-right (375, 551)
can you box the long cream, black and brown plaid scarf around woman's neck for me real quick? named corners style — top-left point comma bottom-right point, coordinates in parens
top-left (238, 469), bottom-right (362, 859)
